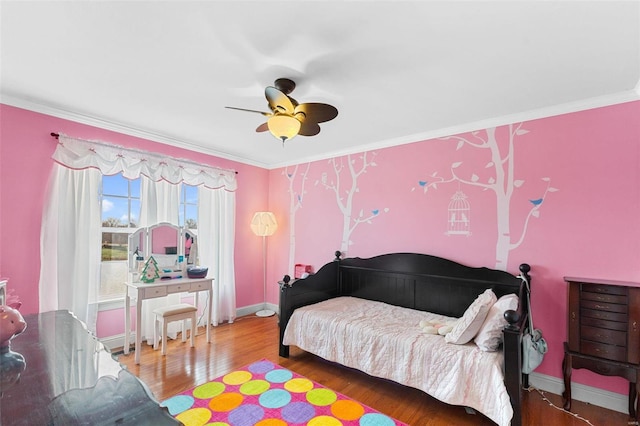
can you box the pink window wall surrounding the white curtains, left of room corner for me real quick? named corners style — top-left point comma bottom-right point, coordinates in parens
top-left (0, 105), bottom-right (268, 328)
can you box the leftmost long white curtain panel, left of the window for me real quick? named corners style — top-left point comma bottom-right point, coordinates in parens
top-left (39, 164), bottom-right (102, 333)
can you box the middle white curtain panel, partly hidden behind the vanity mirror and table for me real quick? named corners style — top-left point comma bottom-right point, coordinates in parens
top-left (140, 176), bottom-right (181, 345)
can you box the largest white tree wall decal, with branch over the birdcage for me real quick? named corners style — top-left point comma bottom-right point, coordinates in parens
top-left (414, 123), bottom-right (557, 270)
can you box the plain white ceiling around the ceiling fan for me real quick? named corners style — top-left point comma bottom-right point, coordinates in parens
top-left (0, 0), bottom-right (640, 168)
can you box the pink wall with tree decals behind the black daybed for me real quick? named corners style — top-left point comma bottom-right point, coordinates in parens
top-left (269, 102), bottom-right (640, 394)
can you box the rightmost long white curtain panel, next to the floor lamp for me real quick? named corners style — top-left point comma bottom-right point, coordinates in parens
top-left (198, 186), bottom-right (236, 323)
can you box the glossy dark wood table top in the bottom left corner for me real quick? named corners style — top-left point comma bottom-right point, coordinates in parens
top-left (0, 311), bottom-right (180, 426)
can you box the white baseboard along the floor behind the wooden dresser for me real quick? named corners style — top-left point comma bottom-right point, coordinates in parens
top-left (529, 373), bottom-right (629, 414)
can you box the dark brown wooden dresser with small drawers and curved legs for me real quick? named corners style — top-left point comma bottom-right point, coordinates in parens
top-left (562, 277), bottom-right (640, 419)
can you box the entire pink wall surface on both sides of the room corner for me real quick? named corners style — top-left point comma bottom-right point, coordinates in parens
top-left (0, 102), bottom-right (640, 400)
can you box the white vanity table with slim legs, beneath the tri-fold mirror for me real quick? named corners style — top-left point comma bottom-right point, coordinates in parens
top-left (124, 278), bottom-right (218, 364)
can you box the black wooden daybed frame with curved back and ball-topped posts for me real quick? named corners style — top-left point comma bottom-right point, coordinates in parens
top-left (279, 252), bottom-right (530, 426)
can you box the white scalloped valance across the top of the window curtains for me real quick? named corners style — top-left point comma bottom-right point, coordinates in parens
top-left (53, 134), bottom-right (237, 191)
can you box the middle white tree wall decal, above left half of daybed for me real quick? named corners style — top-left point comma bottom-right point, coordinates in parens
top-left (315, 152), bottom-right (389, 254)
